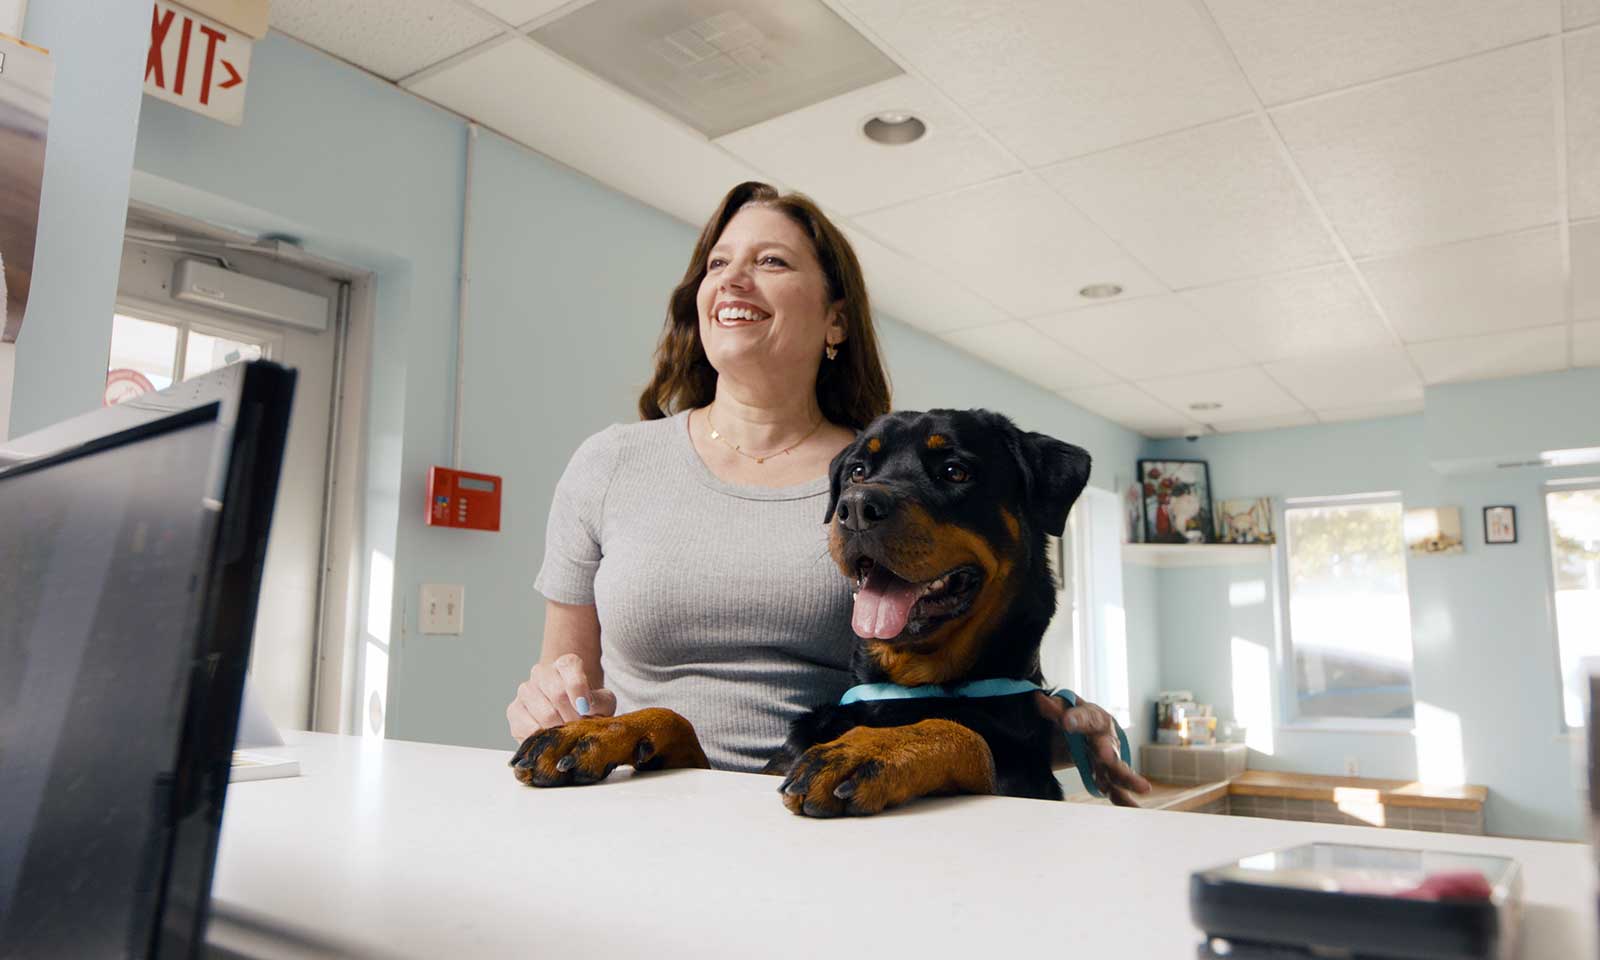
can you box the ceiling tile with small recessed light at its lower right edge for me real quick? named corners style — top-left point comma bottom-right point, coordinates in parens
top-left (854, 174), bottom-right (1163, 317)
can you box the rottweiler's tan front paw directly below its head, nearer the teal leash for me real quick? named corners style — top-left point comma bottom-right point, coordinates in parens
top-left (779, 720), bottom-right (995, 818)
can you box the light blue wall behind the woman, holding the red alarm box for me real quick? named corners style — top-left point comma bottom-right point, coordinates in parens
top-left (116, 35), bottom-right (1154, 746)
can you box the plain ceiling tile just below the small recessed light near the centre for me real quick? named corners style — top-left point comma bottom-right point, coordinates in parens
top-left (1032, 294), bottom-right (1248, 381)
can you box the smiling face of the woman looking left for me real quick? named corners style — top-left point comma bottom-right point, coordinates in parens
top-left (696, 206), bottom-right (843, 382)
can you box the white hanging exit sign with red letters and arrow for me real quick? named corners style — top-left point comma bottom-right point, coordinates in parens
top-left (144, 0), bottom-right (254, 126)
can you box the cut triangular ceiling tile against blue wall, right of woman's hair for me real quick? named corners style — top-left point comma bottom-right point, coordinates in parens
top-left (840, 226), bottom-right (1011, 333)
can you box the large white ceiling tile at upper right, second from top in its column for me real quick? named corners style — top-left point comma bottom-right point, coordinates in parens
top-left (1272, 40), bottom-right (1558, 256)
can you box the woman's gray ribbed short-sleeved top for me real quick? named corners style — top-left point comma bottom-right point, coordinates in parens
top-left (534, 413), bottom-right (856, 771)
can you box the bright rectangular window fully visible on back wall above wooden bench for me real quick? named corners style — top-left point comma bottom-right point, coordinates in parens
top-left (1283, 499), bottom-right (1414, 722)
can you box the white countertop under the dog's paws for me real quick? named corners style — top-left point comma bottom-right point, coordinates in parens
top-left (213, 733), bottom-right (1597, 960)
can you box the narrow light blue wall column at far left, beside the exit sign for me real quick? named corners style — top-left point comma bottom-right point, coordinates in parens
top-left (10, 0), bottom-right (150, 437)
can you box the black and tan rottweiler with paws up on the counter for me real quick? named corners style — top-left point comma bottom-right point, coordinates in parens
top-left (512, 410), bottom-right (1090, 818)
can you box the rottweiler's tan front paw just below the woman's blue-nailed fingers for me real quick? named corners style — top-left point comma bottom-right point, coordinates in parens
top-left (510, 707), bottom-right (710, 787)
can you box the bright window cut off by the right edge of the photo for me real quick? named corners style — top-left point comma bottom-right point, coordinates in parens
top-left (1544, 483), bottom-right (1600, 726)
